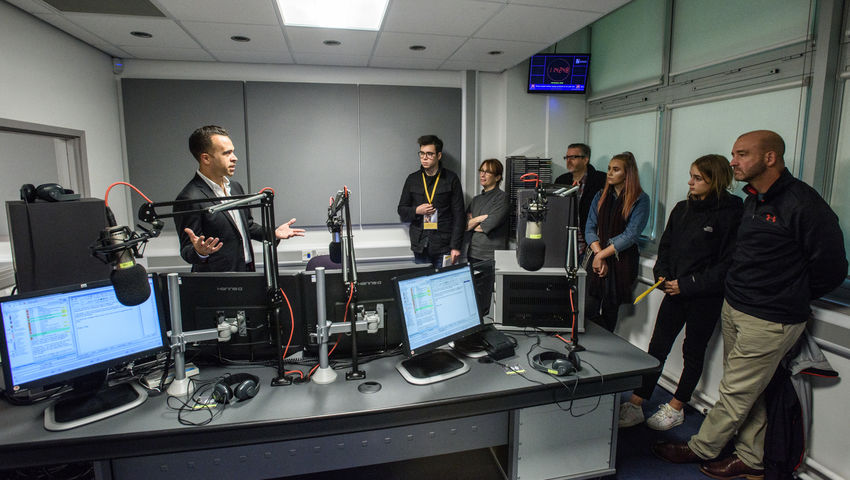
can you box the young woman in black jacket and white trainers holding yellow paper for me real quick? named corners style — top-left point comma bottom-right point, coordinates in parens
top-left (619, 155), bottom-right (743, 430)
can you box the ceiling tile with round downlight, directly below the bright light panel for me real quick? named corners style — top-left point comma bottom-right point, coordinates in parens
top-left (285, 27), bottom-right (378, 55)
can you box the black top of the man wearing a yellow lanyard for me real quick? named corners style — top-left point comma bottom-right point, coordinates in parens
top-left (398, 167), bottom-right (466, 255)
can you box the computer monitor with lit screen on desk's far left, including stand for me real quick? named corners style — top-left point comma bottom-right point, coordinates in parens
top-left (0, 276), bottom-right (167, 430)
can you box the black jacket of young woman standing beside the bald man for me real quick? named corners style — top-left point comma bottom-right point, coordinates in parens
top-left (653, 194), bottom-right (744, 297)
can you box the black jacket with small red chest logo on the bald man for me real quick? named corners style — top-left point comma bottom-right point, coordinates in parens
top-left (726, 169), bottom-right (847, 323)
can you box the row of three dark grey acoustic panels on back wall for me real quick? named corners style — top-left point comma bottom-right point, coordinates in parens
top-left (122, 79), bottom-right (461, 228)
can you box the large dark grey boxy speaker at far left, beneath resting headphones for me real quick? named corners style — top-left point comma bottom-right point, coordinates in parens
top-left (6, 198), bottom-right (112, 293)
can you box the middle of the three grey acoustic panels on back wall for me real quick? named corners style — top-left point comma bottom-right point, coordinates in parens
top-left (245, 82), bottom-right (360, 227)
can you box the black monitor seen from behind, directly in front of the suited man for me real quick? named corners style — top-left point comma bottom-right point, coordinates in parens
top-left (178, 272), bottom-right (303, 365)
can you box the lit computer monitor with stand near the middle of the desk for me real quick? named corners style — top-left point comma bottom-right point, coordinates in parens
top-left (393, 264), bottom-right (484, 384)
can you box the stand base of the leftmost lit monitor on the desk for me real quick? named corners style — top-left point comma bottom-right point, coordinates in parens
top-left (44, 382), bottom-right (148, 432)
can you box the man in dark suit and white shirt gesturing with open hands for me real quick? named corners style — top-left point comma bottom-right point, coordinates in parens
top-left (174, 125), bottom-right (304, 272)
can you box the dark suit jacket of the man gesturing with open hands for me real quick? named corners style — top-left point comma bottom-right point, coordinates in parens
top-left (174, 173), bottom-right (263, 272)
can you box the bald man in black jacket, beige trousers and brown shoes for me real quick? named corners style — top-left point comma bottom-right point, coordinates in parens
top-left (652, 130), bottom-right (847, 479)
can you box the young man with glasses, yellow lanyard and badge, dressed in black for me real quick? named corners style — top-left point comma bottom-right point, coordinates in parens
top-left (398, 135), bottom-right (466, 268)
